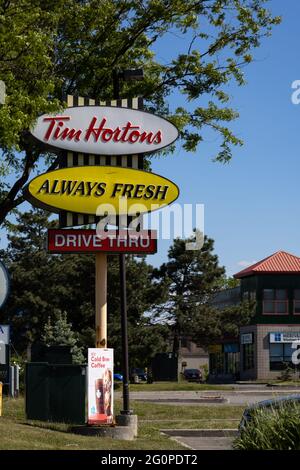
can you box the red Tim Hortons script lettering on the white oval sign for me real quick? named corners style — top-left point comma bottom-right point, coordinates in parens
top-left (43, 116), bottom-right (162, 144)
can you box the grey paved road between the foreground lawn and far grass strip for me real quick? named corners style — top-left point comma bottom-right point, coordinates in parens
top-left (116, 388), bottom-right (300, 406)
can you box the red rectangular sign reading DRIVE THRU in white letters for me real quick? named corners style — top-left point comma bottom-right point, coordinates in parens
top-left (47, 229), bottom-right (157, 254)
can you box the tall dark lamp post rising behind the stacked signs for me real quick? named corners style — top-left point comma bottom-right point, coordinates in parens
top-left (113, 69), bottom-right (144, 415)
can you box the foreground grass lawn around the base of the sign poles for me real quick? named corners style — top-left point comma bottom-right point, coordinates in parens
top-left (0, 398), bottom-right (244, 450)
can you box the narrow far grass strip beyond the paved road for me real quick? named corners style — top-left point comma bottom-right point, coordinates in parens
top-left (127, 381), bottom-right (233, 392)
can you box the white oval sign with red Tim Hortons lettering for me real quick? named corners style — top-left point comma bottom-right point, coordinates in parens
top-left (31, 106), bottom-right (178, 155)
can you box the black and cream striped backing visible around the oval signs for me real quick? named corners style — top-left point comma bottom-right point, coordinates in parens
top-left (59, 95), bottom-right (144, 228)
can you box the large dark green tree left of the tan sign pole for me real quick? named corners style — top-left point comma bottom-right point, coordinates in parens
top-left (1, 209), bottom-right (94, 352)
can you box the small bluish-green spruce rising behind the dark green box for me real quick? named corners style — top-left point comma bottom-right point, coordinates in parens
top-left (42, 312), bottom-right (85, 364)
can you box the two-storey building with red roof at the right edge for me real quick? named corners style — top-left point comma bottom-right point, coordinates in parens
top-left (210, 251), bottom-right (300, 380)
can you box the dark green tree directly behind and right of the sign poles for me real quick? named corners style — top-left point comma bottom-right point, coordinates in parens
top-left (107, 256), bottom-right (169, 367)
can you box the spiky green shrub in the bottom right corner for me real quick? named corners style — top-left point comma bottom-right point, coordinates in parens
top-left (234, 403), bottom-right (300, 450)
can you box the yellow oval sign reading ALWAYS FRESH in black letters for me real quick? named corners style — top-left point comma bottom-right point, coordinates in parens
top-left (26, 166), bottom-right (179, 215)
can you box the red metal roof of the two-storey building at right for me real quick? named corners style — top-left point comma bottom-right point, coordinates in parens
top-left (234, 251), bottom-right (300, 278)
